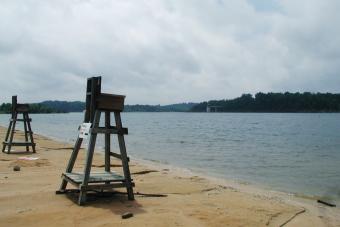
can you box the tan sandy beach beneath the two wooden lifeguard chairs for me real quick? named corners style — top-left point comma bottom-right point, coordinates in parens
top-left (0, 127), bottom-right (340, 227)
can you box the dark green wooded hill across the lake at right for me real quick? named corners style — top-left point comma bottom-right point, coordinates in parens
top-left (191, 92), bottom-right (340, 112)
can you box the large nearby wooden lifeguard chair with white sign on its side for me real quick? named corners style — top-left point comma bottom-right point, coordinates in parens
top-left (56, 77), bottom-right (134, 205)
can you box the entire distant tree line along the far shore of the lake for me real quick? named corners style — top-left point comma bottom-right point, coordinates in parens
top-left (0, 92), bottom-right (340, 113)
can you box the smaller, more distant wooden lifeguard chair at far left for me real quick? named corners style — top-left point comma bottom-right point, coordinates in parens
top-left (2, 95), bottom-right (35, 154)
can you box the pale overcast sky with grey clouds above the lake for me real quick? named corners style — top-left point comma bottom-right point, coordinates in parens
top-left (0, 0), bottom-right (340, 104)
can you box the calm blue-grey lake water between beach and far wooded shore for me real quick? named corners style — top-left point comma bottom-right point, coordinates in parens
top-left (0, 113), bottom-right (340, 204)
